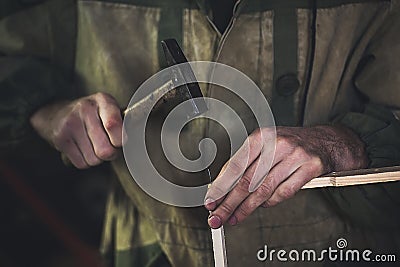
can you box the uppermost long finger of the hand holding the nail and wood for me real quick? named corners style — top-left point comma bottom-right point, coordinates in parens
top-left (205, 130), bottom-right (263, 206)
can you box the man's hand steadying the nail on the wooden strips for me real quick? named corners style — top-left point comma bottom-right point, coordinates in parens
top-left (205, 126), bottom-right (368, 228)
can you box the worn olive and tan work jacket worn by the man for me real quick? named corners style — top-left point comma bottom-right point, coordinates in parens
top-left (0, 0), bottom-right (400, 267)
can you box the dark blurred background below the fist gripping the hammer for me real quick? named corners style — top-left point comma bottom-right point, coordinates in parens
top-left (0, 140), bottom-right (109, 267)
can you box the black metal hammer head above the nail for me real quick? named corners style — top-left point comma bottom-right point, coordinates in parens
top-left (161, 39), bottom-right (208, 117)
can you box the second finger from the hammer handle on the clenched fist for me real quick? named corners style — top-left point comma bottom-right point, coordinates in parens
top-left (83, 106), bottom-right (116, 160)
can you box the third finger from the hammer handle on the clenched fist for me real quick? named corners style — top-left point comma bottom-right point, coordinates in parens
top-left (74, 122), bottom-right (102, 166)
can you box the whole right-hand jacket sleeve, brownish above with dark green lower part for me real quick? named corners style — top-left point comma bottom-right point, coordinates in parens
top-left (325, 6), bottom-right (400, 230)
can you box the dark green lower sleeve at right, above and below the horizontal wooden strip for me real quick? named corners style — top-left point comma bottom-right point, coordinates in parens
top-left (326, 105), bottom-right (400, 229)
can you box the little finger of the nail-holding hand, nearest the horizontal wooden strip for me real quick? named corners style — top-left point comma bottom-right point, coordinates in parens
top-left (263, 166), bottom-right (313, 207)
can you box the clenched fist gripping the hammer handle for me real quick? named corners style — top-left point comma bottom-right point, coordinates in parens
top-left (30, 93), bottom-right (122, 169)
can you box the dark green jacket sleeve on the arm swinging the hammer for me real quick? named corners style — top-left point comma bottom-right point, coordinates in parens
top-left (0, 0), bottom-right (75, 152)
